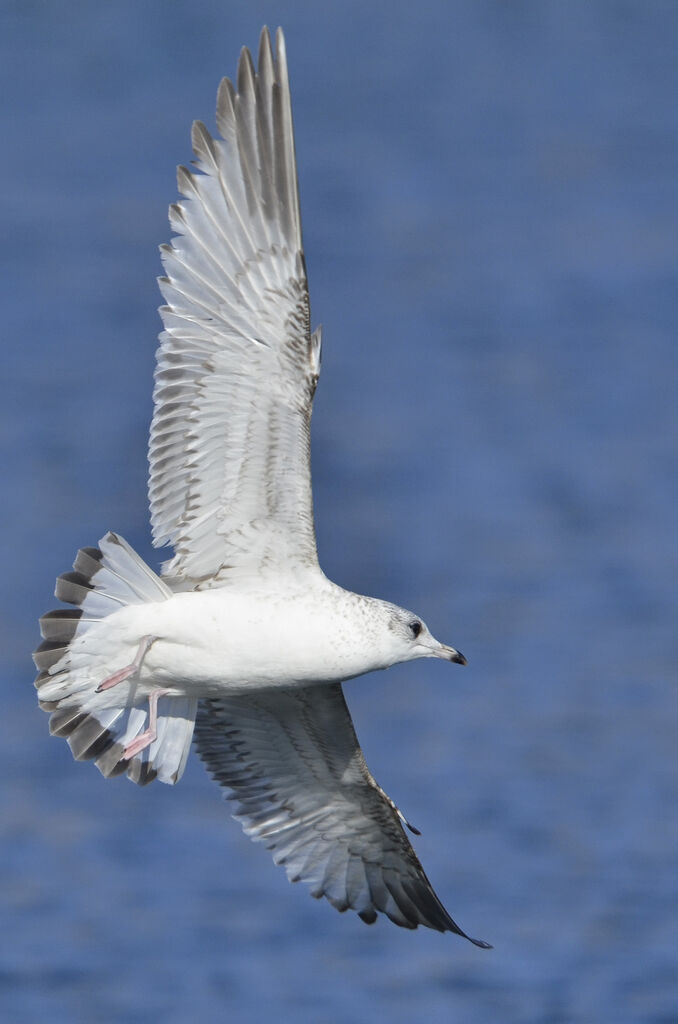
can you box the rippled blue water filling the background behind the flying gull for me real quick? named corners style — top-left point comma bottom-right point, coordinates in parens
top-left (0, 0), bottom-right (678, 1024)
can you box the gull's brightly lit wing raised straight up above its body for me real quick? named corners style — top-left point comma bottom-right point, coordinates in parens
top-left (149, 29), bottom-right (320, 587)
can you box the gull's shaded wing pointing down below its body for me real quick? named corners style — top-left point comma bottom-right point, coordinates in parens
top-left (195, 684), bottom-right (488, 947)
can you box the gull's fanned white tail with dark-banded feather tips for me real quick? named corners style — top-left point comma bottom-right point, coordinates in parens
top-left (33, 534), bottom-right (198, 785)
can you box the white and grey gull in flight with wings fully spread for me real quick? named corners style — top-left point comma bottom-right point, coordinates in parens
top-left (34, 28), bottom-right (489, 948)
